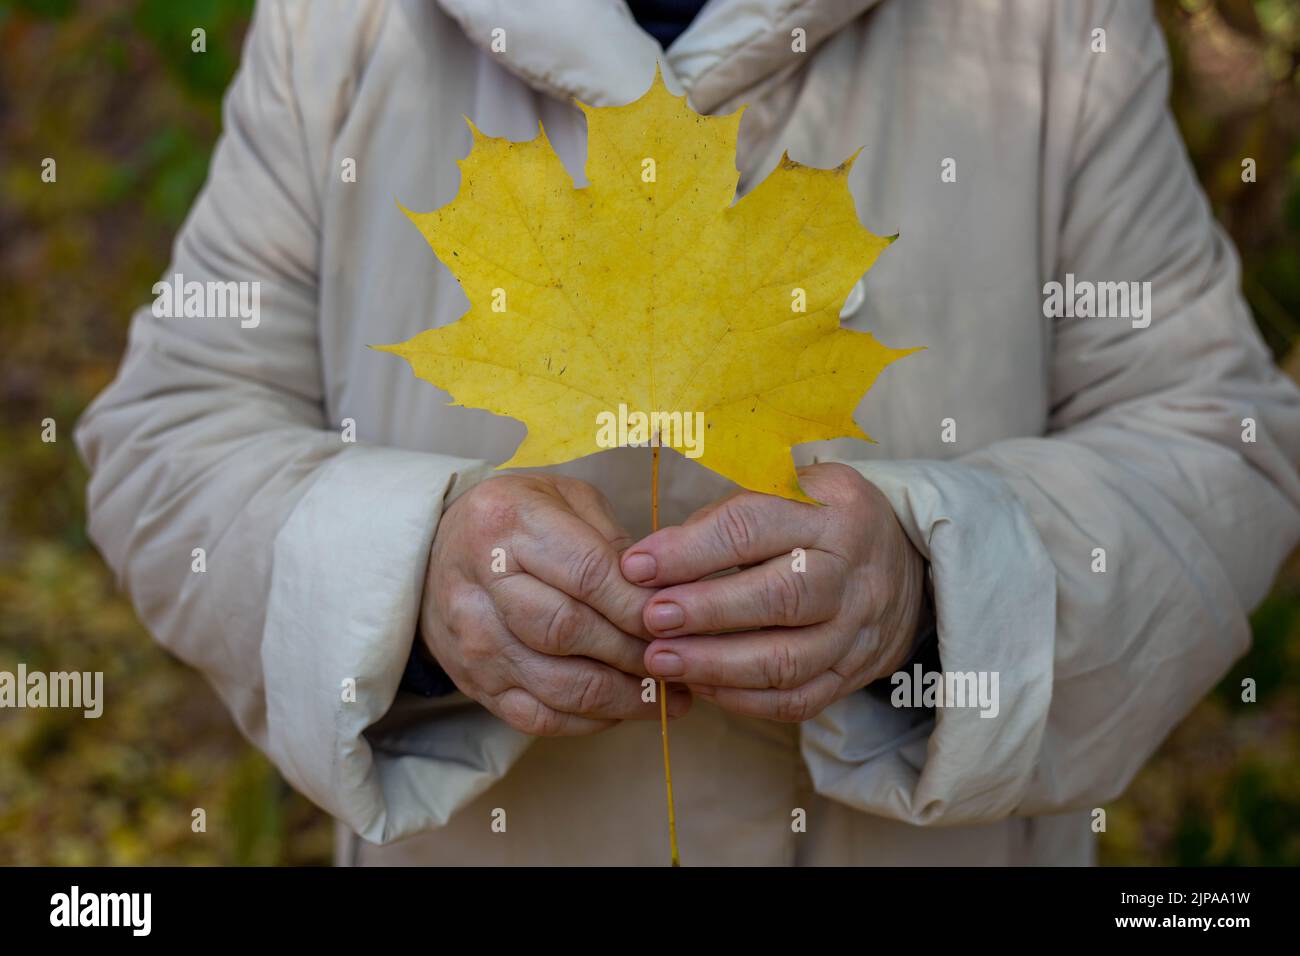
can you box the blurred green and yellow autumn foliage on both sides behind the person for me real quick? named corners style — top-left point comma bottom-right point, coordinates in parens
top-left (0, 0), bottom-right (1300, 865)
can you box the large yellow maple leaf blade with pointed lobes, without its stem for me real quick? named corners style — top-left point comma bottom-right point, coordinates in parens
top-left (376, 72), bottom-right (915, 501)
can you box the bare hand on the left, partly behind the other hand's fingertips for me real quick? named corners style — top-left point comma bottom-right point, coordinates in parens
top-left (420, 475), bottom-right (690, 736)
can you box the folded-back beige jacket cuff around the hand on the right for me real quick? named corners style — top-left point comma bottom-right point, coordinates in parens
top-left (802, 462), bottom-right (1056, 825)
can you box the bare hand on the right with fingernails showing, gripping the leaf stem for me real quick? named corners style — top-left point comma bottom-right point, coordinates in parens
top-left (621, 463), bottom-right (926, 721)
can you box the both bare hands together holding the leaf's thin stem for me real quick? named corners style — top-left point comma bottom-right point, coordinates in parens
top-left (420, 463), bottom-right (926, 736)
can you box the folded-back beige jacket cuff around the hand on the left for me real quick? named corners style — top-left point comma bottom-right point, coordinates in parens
top-left (261, 446), bottom-right (528, 843)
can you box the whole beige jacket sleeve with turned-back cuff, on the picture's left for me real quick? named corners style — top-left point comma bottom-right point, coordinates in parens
top-left (77, 4), bottom-right (524, 842)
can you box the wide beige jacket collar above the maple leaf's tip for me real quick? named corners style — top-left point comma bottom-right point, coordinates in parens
top-left (438, 0), bottom-right (879, 112)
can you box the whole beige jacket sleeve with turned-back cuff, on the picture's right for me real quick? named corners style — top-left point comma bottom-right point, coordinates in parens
top-left (802, 4), bottom-right (1300, 825)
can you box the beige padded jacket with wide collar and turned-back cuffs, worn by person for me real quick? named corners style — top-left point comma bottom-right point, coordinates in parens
top-left (78, 0), bottom-right (1300, 864)
